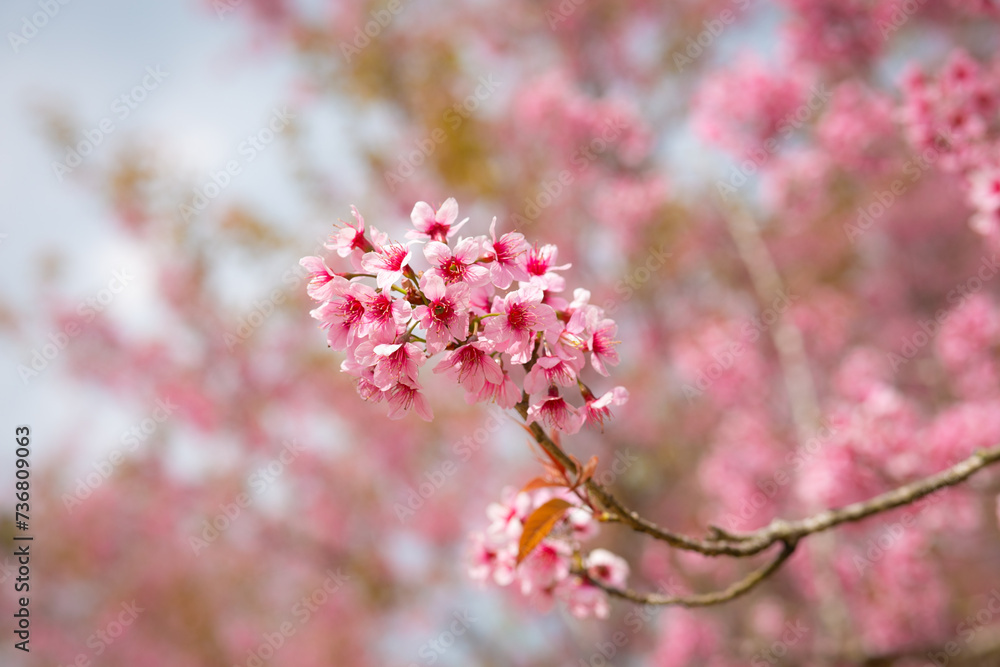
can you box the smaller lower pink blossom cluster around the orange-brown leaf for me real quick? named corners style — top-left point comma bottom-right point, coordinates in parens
top-left (469, 488), bottom-right (629, 618)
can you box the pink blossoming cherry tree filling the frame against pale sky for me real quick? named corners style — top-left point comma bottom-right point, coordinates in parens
top-left (4, 0), bottom-right (1000, 667)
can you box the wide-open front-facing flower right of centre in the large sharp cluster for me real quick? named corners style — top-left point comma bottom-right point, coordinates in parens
top-left (482, 285), bottom-right (557, 364)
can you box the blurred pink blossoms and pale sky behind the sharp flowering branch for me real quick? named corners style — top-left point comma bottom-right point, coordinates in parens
top-left (0, 0), bottom-right (1000, 667)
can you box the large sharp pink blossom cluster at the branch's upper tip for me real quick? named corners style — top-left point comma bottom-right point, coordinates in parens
top-left (301, 199), bottom-right (628, 433)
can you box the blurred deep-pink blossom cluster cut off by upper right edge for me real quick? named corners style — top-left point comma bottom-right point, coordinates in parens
top-left (903, 49), bottom-right (1000, 240)
